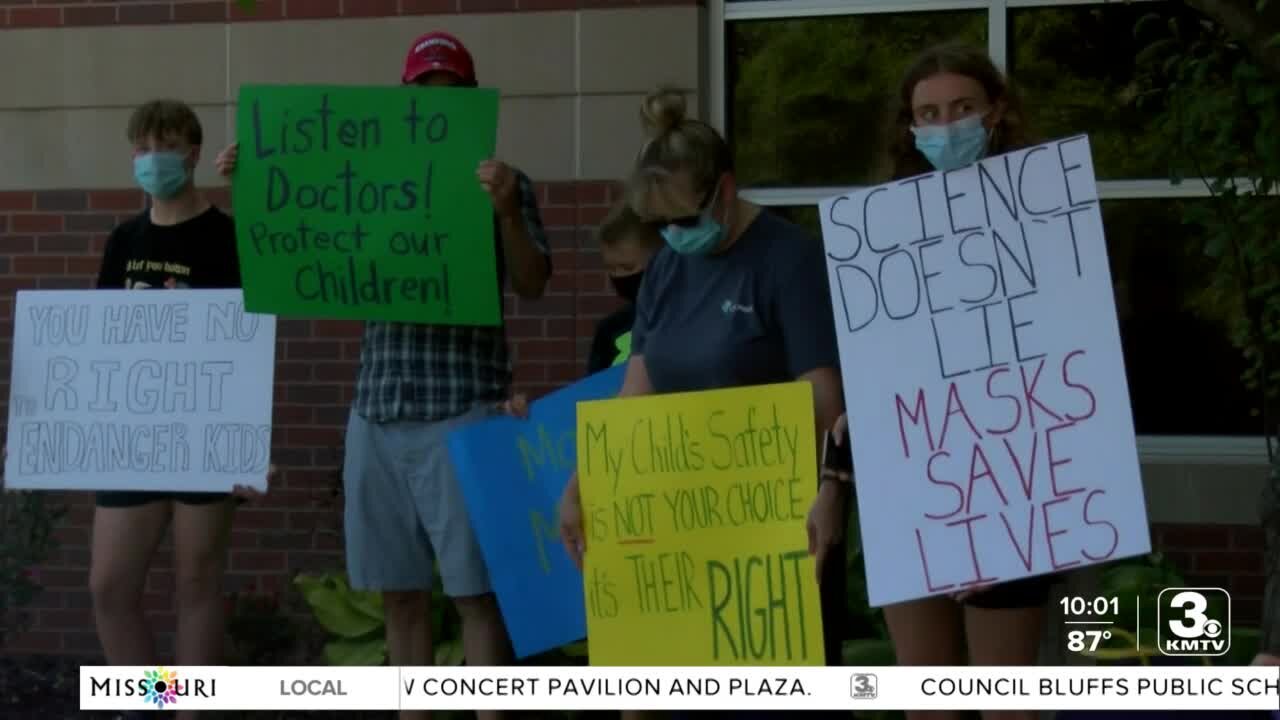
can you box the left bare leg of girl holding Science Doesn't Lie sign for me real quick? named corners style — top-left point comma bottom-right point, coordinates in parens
top-left (884, 597), bottom-right (965, 720)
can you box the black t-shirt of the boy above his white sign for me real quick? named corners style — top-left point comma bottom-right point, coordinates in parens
top-left (97, 208), bottom-right (241, 290)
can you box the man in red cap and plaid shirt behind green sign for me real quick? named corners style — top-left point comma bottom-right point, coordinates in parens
top-left (218, 32), bottom-right (552, 717)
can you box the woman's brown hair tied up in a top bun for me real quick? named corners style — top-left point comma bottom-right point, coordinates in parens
top-left (627, 87), bottom-right (733, 218)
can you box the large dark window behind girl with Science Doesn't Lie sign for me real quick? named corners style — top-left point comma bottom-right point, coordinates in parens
top-left (712, 0), bottom-right (1262, 461)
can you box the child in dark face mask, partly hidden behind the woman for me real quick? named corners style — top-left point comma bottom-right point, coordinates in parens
top-left (586, 197), bottom-right (662, 374)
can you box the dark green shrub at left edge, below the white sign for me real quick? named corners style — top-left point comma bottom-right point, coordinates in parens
top-left (0, 486), bottom-right (67, 646)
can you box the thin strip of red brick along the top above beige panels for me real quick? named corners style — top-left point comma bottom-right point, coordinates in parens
top-left (0, 0), bottom-right (703, 28)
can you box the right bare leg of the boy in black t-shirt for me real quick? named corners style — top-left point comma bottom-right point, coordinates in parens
top-left (173, 498), bottom-right (236, 720)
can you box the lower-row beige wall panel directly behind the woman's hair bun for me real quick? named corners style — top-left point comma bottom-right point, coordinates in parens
top-left (581, 94), bottom-right (701, 179)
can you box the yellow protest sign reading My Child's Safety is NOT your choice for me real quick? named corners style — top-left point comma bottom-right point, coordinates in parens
top-left (577, 382), bottom-right (824, 666)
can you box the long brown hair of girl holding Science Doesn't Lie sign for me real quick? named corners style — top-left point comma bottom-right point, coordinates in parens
top-left (886, 42), bottom-right (1034, 179)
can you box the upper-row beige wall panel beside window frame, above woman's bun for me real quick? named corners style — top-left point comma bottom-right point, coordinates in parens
top-left (580, 8), bottom-right (705, 95)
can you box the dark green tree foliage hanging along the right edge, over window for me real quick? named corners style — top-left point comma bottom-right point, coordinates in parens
top-left (1139, 8), bottom-right (1280, 448)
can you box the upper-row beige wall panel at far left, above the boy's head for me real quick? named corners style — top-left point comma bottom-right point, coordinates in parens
top-left (0, 24), bottom-right (227, 109)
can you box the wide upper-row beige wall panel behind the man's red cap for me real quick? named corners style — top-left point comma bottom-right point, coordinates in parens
top-left (229, 13), bottom-right (573, 100)
